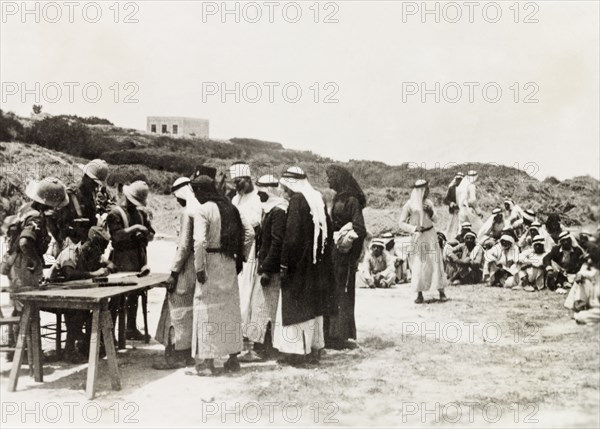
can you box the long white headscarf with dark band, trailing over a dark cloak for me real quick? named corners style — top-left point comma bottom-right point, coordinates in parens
top-left (279, 167), bottom-right (327, 264)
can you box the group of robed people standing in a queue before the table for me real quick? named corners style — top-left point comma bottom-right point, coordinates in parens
top-left (154, 162), bottom-right (366, 375)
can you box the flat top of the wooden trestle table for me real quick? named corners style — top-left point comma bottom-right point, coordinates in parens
top-left (15, 273), bottom-right (169, 302)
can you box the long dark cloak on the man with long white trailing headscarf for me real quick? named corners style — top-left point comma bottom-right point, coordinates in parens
top-left (281, 193), bottom-right (332, 326)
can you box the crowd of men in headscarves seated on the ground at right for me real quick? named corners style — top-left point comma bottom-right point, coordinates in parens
top-left (359, 194), bottom-right (600, 321)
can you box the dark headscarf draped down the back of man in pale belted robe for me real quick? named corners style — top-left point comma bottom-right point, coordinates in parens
top-left (192, 176), bottom-right (244, 273)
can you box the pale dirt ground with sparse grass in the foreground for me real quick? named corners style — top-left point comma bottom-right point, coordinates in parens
top-left (0, 241), bottom-right (600, 428)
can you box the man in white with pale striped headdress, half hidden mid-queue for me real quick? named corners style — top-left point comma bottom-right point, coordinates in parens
top-left (229, 161), bottom-right (262, 362)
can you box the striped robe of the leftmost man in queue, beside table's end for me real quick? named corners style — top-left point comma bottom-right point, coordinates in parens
top-left (156, 210), bottom-right (196, 350)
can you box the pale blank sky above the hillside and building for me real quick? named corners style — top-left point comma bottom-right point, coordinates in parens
top-left (0, 1), bottom-right (600, 180)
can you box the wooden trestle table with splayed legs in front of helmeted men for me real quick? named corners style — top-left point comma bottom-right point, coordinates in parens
top-left (8, 273), bottom-right (169, 399)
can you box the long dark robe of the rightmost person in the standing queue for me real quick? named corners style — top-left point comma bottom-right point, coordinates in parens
top-left (325, 195), bottom-right (367, 342)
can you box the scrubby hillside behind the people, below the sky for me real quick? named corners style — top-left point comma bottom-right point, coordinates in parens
top-left (0, 110), bottom-right (600, 234)
